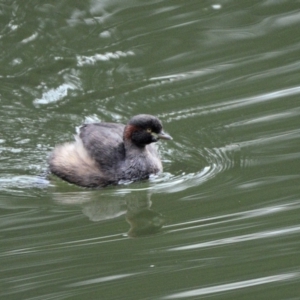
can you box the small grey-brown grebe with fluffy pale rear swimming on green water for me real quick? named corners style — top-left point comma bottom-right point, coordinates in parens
top-left (48, 114), bottom-right (172, 188)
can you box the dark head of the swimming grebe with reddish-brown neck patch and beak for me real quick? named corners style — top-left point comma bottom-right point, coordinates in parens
top-left (124, 115), bottom-right (172, 147)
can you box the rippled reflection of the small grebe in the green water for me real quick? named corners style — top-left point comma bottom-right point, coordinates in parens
top-left (53, 190), bottom-right (165, 237)
